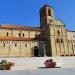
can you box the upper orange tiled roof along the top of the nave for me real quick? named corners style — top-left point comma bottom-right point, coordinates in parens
top-left (0, 24), bottom-right (42, 31)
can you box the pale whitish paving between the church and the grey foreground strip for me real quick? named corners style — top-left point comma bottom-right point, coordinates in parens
top-left (0, 57), bottom-right (75, 70)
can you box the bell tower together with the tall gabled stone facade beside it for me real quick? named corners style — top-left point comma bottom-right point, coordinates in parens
top-left (40, 5), bottom-right (69, 56)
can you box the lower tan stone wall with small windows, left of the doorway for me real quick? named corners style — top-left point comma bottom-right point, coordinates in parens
top-left (0, 41), bottom-right (45, 56)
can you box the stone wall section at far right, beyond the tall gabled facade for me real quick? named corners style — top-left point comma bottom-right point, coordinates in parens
top-left (67, 31), bottom-right (75, 55)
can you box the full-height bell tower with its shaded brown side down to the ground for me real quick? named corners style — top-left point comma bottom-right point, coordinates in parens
top-left (40, 4), bottom-right (54, 56)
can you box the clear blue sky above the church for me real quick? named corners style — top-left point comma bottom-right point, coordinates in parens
top-left (0, 0), bottom-right (75, 30)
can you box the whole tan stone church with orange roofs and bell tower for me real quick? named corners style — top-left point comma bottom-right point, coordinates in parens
top-left (0, 4), bottom-right (75, 57)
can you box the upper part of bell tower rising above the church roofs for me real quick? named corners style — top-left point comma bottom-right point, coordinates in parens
top-left (40, 4), bottom-right (54, 29)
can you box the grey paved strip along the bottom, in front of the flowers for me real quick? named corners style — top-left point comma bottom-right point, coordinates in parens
top-left (0, 68), bottom-right (75, 75)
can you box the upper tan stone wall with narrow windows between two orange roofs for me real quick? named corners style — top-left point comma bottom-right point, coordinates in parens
top-left (0, 28), bottom-right (41, 38)
